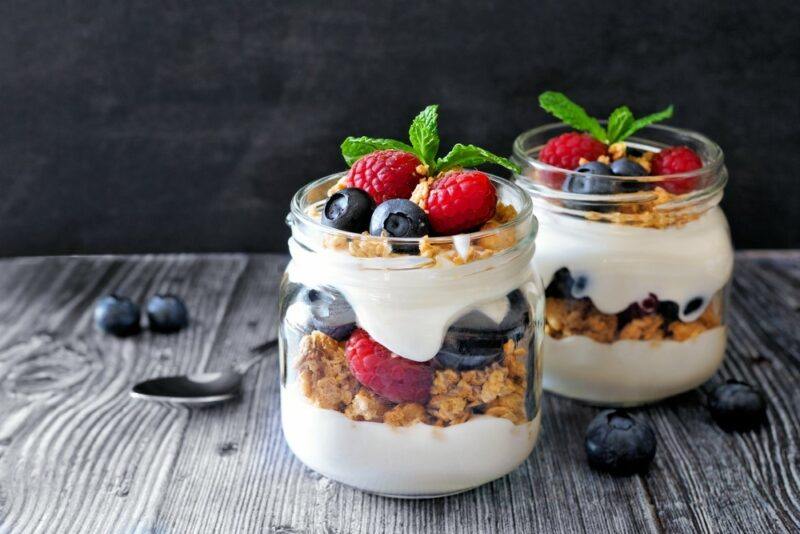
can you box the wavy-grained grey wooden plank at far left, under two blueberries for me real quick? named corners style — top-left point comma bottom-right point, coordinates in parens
top-left (0, 256), bottom-right (246, 532)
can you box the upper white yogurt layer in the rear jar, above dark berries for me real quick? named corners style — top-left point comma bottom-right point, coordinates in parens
top-left (533, 207), bottom-right (733, 321)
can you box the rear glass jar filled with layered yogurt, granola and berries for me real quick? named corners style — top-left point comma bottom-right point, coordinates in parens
top-left (513, 124), bottom-right (733, 406)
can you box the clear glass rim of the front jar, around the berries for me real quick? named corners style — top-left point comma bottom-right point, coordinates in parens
top-left (288, 171), bottom-right (538, 245)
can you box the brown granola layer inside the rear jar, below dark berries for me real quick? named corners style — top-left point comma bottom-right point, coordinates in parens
top-left (545, 297), bottom-right (721, 343)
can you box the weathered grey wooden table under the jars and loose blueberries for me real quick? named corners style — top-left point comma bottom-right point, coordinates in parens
top-left (0, 252), bottom-right (800, 534)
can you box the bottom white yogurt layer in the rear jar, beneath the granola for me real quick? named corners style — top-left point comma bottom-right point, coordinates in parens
top-left (543, 326), bottom-right (727, 405)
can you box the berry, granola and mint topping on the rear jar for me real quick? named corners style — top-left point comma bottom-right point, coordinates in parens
top-left (515, 91), bottom-right (721, 228)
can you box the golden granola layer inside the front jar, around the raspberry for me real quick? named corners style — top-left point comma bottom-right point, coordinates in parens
top-left (296, 331), bottom-right (527, 426)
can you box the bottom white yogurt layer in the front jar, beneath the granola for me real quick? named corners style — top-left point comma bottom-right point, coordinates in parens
top-left (281, 385), bottom-right (541, 497)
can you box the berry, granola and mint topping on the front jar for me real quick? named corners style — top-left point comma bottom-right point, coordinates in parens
top-left (309, 105), bottom-right (520, 264)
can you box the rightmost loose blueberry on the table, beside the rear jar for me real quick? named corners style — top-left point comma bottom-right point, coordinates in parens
top-left (708, 380), bottom-right (767, 432)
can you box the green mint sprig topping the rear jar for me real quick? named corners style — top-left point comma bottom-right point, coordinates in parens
top-left (539, 91), bottom-right (673, 145)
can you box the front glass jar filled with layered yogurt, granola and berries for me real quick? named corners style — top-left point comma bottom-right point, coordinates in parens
top-left (280, 173), bottom-right (544, 497)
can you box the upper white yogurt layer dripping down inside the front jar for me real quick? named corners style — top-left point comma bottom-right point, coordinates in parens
top-left (286, 239), bottom-right (534, 361)
